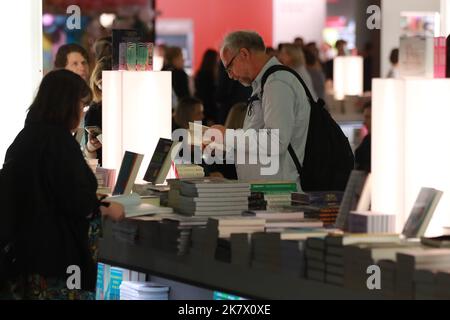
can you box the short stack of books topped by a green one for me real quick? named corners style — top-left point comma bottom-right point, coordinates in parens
top-left (250, 180), bottom-right (297, 210)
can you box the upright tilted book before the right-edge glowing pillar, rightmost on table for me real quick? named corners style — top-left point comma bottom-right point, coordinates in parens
top-left (402, 188), bottom-right (442, 238)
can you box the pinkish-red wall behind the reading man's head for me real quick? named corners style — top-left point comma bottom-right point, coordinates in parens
top-left (156, 0), bottom-right (273, 70)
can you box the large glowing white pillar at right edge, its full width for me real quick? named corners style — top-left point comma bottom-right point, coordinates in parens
top-left (372, 78), bottom-right (450, 236)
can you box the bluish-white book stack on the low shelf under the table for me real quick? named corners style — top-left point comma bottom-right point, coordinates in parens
top-left (120, 281), bottom-right (169, 300)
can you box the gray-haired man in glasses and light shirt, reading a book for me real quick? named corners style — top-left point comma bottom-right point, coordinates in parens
top-left (213, 31), bottom-right (311, 190)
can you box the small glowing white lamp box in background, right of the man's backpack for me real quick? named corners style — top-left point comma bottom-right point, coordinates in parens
top-left (333, 56), bottom-right (363, 100)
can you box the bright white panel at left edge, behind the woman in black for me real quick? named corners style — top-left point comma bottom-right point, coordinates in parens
top-left (0, 0), bottom-right (42, 162)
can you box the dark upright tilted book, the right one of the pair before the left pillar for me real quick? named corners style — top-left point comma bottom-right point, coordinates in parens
top-left (144, 138), bottom-right (181, 185)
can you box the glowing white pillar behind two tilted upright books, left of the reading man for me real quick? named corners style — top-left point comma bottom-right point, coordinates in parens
top-left (102, 71), bottom-right (172, 182)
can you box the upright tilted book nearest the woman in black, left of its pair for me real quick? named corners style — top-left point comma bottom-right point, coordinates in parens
top-left (113, 151), bottom-right (144, 195)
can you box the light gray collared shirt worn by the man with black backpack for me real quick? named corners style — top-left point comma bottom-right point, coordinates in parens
top-left (236, 57), bottom-right (311, 190)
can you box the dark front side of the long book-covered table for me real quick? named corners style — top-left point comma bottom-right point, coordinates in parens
top-left (99, 222), bottom-right (384, 300)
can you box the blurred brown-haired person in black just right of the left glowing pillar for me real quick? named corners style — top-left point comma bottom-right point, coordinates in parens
top-left (162, 47), bottom-right (191, 100)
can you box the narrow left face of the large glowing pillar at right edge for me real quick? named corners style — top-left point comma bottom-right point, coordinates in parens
top-left (371, 79), bottom-right (406, 231)
